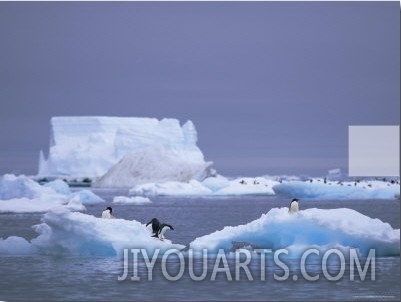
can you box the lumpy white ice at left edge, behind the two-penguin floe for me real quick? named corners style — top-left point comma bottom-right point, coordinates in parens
top-left (0, 174), bottom-right (105, 213)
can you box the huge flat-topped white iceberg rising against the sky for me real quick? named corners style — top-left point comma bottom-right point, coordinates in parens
top-left (38, 116), bottom-right (212, 186)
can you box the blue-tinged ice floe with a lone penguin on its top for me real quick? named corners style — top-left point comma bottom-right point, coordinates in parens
top-left (190, 208), bottom-right (400, 257)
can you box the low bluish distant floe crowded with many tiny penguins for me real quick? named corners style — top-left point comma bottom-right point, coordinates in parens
top-left (273, 179), bottom-right (400, 199)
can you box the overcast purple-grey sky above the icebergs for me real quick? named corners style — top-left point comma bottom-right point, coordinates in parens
top-left (0, 1), bottom-right (400, 176)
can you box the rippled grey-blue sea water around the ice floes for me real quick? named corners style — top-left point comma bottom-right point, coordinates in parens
top-left (0, 189), bottom-right (400, 301)
